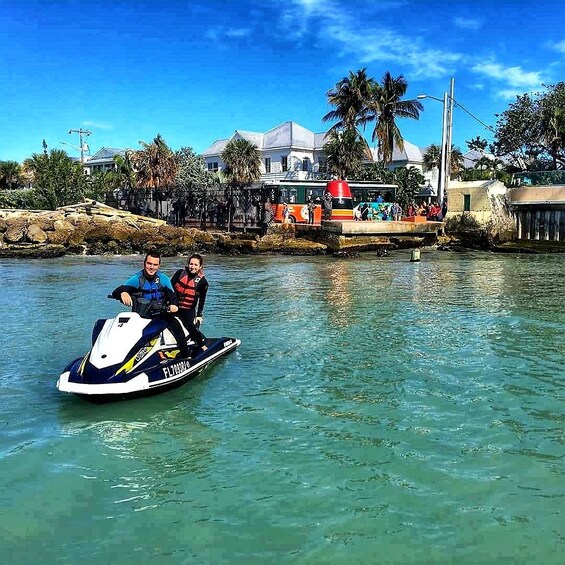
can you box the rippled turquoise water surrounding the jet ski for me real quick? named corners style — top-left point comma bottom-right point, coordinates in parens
top-left (0, 252), bottom-right (565, 564)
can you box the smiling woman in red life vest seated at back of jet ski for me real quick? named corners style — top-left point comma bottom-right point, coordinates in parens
top-left (171, 253), bottom-right (208, 351)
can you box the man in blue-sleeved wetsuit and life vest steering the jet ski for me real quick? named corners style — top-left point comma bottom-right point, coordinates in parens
top-left (112, 251), bottom-right (189, 357)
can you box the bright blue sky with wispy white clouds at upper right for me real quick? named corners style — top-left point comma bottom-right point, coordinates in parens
top-left (0, 0), bottom-right (565, 161)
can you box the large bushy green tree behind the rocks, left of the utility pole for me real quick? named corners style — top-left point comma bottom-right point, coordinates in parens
top-left (24, 149), bottom-right (91, 210)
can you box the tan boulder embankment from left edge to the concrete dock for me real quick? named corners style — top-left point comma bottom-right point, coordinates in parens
top-left (0, 201), bottom-right (328, 258)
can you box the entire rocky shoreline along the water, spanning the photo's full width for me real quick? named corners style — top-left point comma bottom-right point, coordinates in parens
top-left (0, 201), bottom-right (565, 258)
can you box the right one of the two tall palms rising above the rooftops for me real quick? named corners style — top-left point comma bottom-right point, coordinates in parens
top-left (368, 71), bottom-right (424, 165)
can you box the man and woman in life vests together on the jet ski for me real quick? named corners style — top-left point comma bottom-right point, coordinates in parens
top-left (112, 251), bottom-right (208, 358)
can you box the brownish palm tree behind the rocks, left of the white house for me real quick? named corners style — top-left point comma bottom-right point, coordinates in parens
top-left (130, 134), bottom-right (177, 215)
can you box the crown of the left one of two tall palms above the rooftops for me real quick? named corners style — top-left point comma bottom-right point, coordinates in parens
top-left (322, 68), bottom-right (376, 133)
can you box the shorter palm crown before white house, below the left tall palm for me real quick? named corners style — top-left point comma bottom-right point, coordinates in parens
top-left (324, 128), bottom-right (367, 179)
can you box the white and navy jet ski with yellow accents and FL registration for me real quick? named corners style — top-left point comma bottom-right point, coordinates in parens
top-left (57, 298), bottom-right (241, 403)
